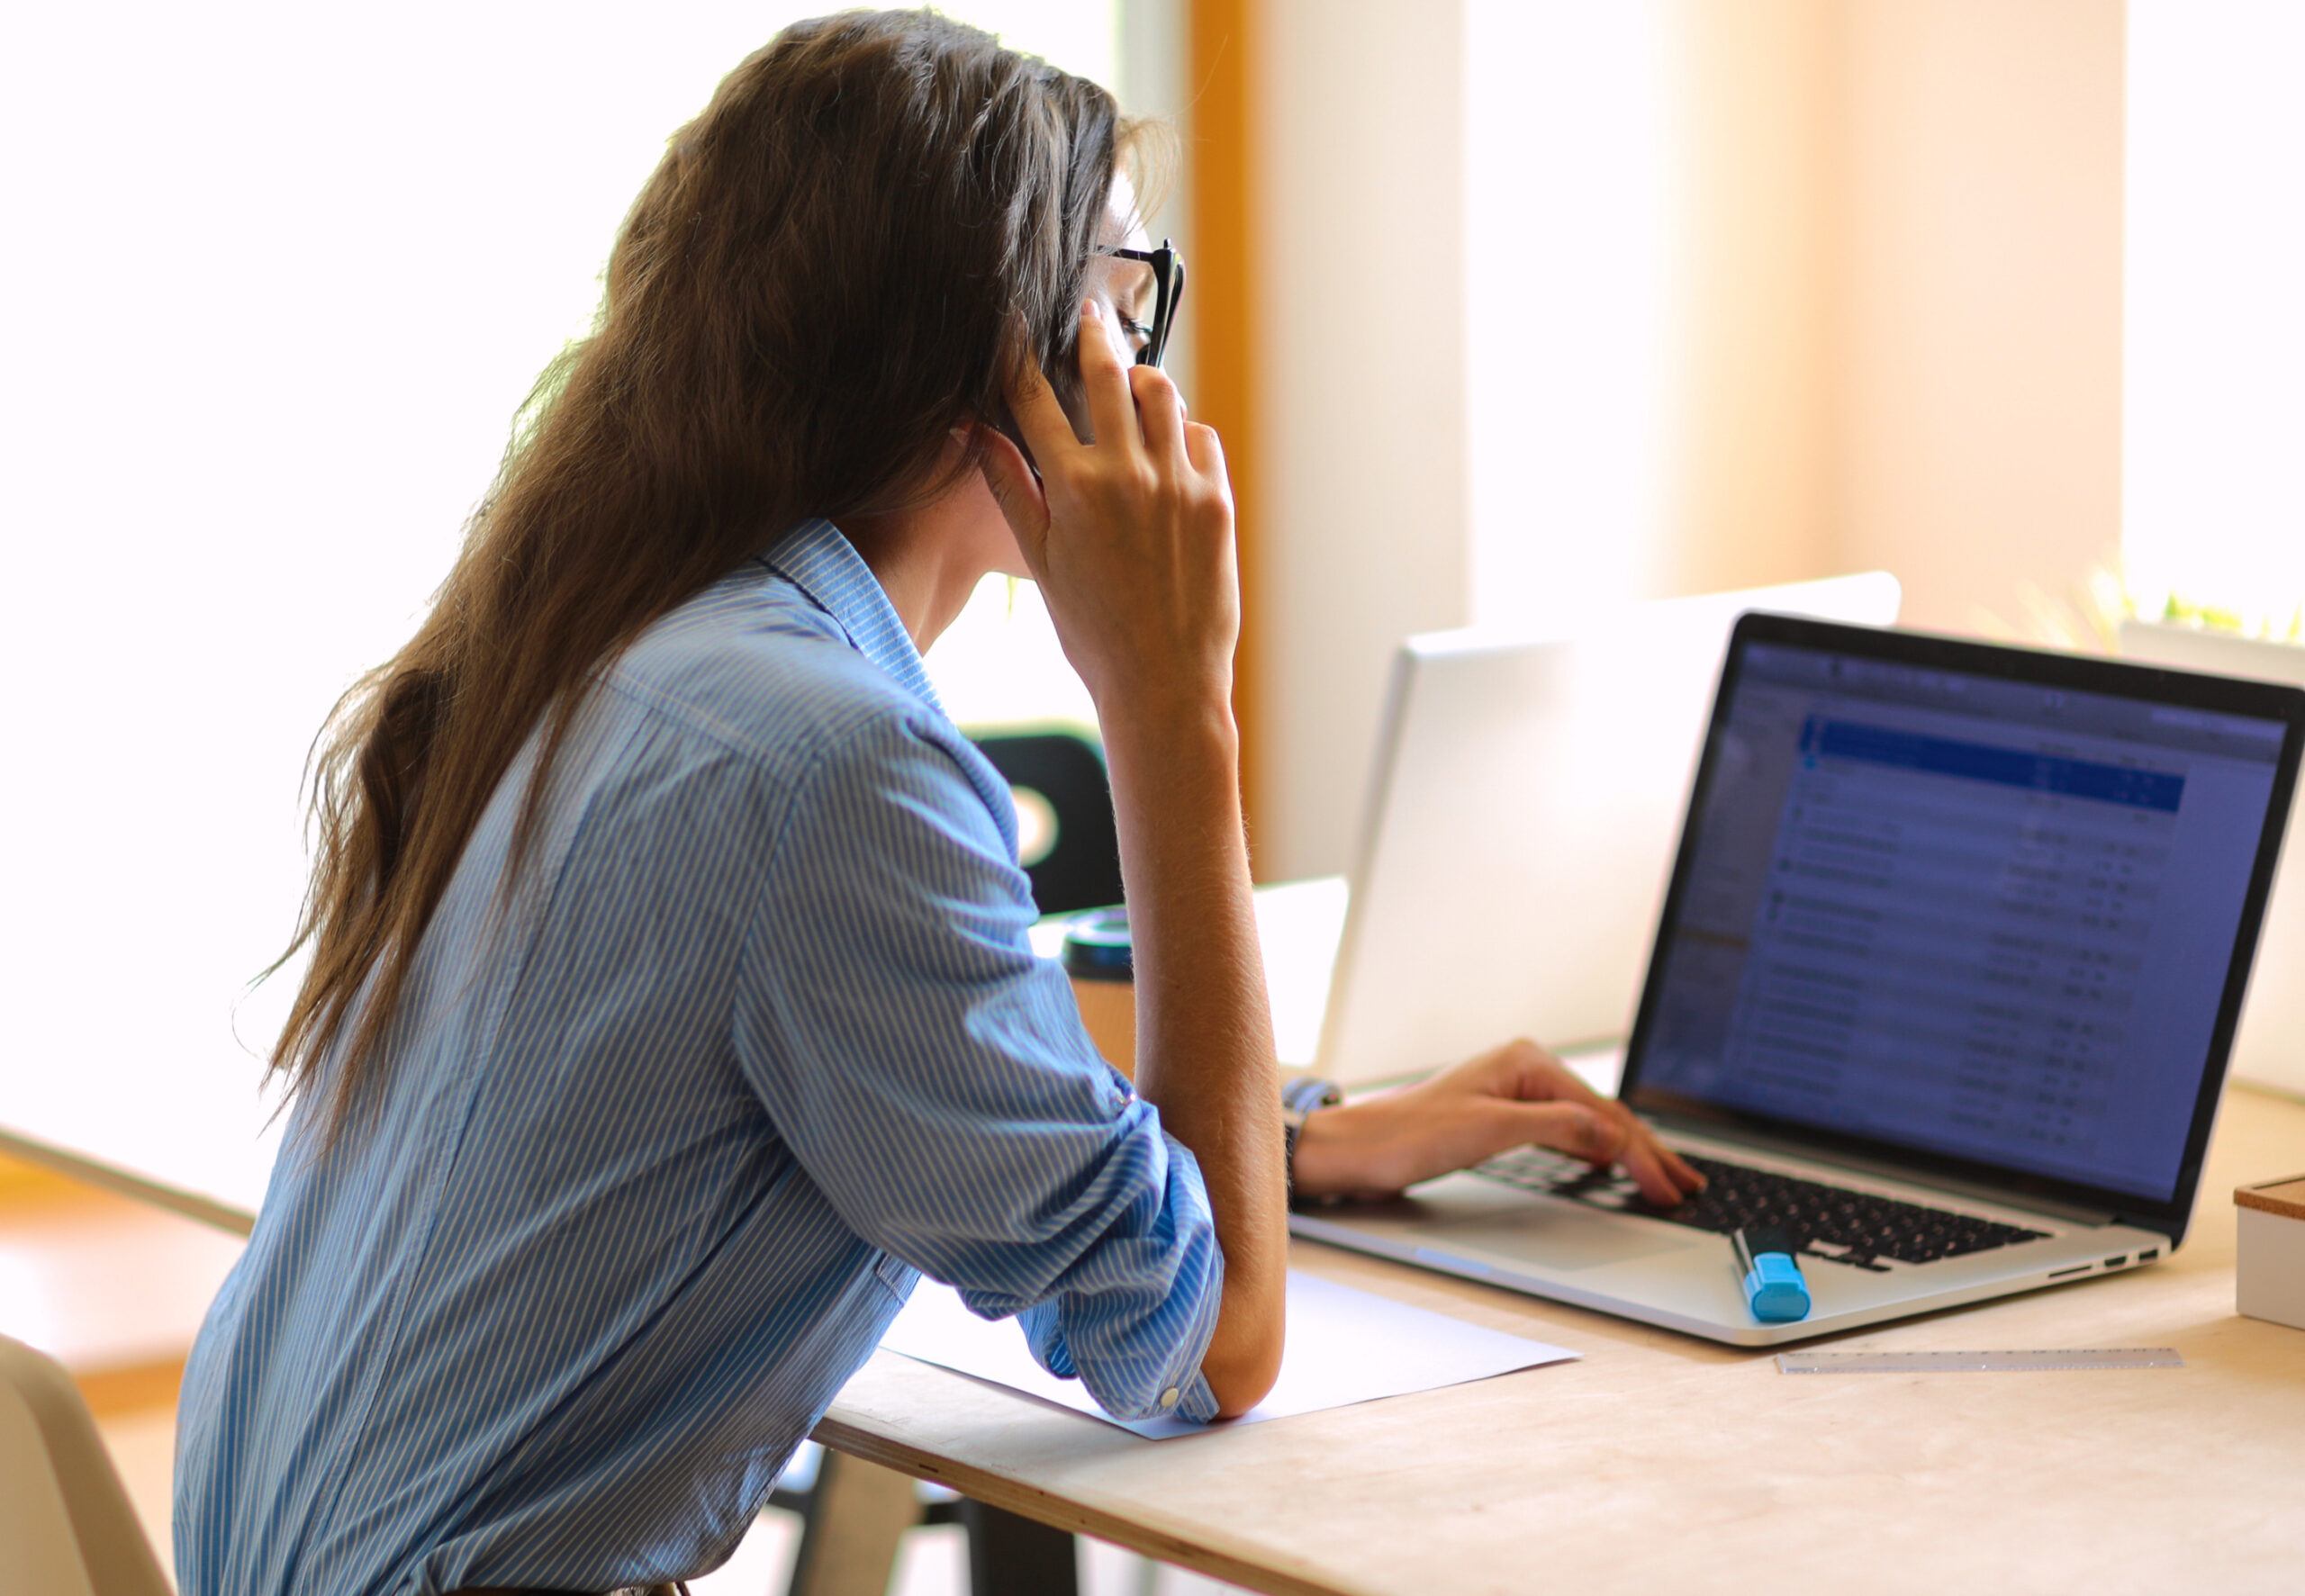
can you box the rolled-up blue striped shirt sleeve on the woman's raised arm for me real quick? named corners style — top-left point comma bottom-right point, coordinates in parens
top-left (733, 712), bottom-right (1224, 1419)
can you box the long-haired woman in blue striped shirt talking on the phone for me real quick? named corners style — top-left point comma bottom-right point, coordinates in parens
top-left (177, 14), bottom-right (1692, 1596)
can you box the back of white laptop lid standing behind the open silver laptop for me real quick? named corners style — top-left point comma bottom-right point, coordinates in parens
top-left (1316, 571), bottom-right (1899, 1085)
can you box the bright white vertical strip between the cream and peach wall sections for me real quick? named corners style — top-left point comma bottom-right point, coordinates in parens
top-left (1466, 0), bottom-right (1685, 631)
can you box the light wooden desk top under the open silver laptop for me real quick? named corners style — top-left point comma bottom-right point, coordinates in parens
top-left (818, 1087), bottom-right (2305, 1596)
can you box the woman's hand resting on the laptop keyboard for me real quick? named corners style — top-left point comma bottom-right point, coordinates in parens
top-left (1296, 1041), bottom-right (1705, 1207)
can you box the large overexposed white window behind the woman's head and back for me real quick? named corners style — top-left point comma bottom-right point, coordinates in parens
top-left (0, 0), bottom-right (1118, 1179)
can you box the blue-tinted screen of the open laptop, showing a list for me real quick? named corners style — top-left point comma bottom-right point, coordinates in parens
top-left (1637, 634), bottom-right (2287, 1203)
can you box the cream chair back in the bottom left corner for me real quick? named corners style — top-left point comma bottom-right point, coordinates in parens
top-left (0, 1336), bottom-right (170, 1596)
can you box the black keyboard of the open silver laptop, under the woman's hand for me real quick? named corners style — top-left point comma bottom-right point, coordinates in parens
top-left (1473, 1147), bottom-right (2049, 1274)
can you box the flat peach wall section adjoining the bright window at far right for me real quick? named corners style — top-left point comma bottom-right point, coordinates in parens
top-left (1835, 0), bottom-right (2123, 631)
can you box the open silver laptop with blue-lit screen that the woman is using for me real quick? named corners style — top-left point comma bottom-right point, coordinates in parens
top-left (1291, 615), bottom-right (2305, 1345)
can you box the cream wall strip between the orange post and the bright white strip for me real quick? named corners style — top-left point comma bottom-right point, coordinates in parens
top-left (1244, 0), bottom-right (1466, 879)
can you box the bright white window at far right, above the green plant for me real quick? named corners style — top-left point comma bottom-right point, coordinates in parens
top-left (2120, 0), bottom-right (2305, 636)
